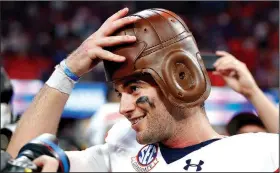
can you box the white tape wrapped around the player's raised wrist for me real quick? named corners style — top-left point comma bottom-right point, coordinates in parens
top-left (46, 65), bottom-right (77, 95)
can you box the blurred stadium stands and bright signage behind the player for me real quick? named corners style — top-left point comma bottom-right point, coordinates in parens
top-left (1, 1), bottom-right (279, 148)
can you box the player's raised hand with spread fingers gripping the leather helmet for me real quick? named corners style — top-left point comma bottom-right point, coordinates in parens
top-left (66, 8), bottom-right (138, 76)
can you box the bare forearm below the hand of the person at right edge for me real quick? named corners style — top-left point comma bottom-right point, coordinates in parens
top-left (247, 88), bottom-right (279, 133)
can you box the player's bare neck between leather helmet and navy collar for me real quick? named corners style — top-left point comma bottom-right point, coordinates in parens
top-left (162, 108), bottom-right (222, 148)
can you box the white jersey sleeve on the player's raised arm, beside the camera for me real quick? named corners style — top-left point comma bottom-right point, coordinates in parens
top-left (66, 144), bottom-right (110, 172)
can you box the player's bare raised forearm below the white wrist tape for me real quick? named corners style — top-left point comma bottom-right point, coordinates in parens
top-left (7, 85), bottom-right (69, 157)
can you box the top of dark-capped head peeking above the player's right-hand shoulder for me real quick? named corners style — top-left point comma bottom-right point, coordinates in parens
top-left (226, 112), bottom-right (267, 136)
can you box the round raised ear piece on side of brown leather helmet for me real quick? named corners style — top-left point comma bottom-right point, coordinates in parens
top-left (162, 50), bottom-right (207, 104)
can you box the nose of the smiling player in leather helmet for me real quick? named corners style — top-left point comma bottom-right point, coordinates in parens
top-left (119, 93), bottom-right (135, 118)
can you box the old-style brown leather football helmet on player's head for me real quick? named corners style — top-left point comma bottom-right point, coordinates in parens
top-left (104, 9), bottom-right (211, 107)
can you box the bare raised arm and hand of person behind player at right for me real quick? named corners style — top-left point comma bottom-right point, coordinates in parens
top-left (214, 51), bottom-right (279, 133)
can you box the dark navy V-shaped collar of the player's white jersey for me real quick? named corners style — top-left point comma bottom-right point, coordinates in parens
top-left (159, 138), bottom-right (221, 164)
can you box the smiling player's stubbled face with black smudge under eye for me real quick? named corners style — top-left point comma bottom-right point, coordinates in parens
top-left (115, 75), bottom-right (174, 144)
